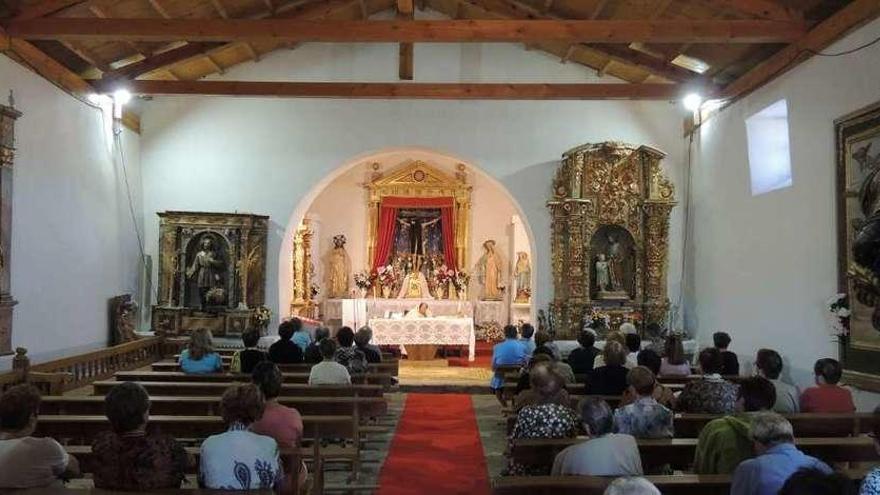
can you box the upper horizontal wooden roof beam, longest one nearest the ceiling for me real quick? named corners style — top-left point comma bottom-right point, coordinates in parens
top-left (7, 18), bottom-right (806, 43)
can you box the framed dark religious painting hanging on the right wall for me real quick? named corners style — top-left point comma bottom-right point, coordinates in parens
top-left (833, 103), bottom-right (880, 391)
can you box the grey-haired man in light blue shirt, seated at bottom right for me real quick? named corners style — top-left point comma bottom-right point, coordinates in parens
top-left (730, 412), bottom-right (831, 495)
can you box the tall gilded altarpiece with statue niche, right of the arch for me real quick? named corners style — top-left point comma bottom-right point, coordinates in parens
top-left (548, 142), bottom-right (676, 338)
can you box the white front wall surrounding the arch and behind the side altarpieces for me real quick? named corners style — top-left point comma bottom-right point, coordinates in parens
top-left (142, 38), bottom-right (683, 334)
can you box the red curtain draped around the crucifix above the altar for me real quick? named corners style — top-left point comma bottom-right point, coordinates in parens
top-left (373, 196), bottom-right (457, 269)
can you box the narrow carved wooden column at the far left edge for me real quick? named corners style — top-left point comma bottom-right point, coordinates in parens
top-left (0, 92), bottom-right (21, 356)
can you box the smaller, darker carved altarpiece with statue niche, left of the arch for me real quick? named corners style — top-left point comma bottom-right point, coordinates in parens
top-left (152, 211), bottom-right (269, 335)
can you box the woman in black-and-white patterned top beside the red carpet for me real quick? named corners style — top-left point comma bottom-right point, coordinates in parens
top-left (504, 367), bottom-right (579, 476)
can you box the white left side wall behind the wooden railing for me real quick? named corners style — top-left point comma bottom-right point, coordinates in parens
top-left (0, 57), bottom-right (143, 368)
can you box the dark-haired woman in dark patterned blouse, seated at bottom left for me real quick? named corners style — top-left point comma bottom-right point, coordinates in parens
top-left (92, 382), bottom-right (190, 490)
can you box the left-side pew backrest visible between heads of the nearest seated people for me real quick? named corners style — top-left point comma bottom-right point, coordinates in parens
top-left (40, 395), bottom-right (388, 418)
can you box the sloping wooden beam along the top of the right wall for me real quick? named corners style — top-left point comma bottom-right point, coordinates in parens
top-left (722, 0), bottom-right (880, 99)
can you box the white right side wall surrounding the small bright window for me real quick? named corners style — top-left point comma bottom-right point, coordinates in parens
top-left (686, 17), bottom-right (880, 407)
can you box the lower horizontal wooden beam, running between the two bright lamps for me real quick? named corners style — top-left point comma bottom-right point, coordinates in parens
top-left (122, 80), bottom-right (696, 100)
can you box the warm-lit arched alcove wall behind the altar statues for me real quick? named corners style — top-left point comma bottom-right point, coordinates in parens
top-left (278, 147), bottom-right (537, 322)
